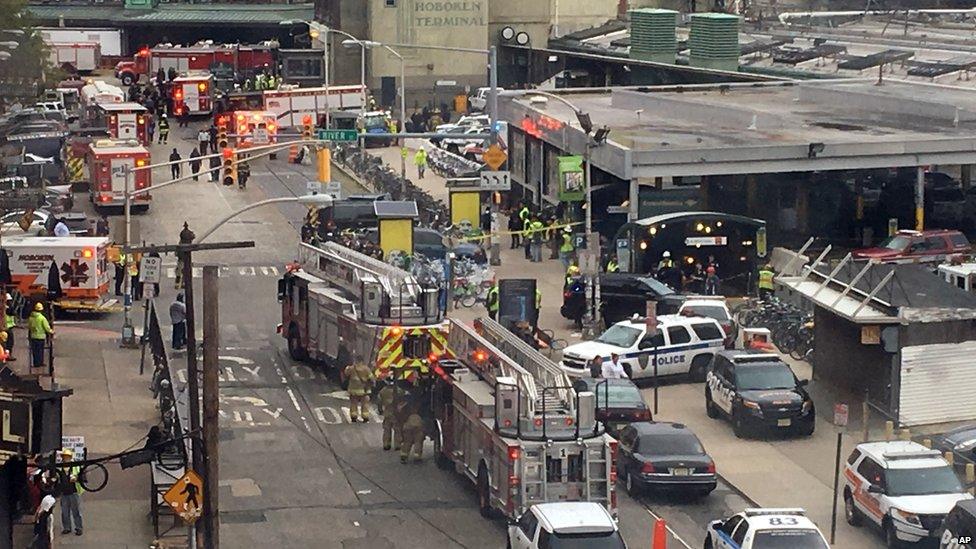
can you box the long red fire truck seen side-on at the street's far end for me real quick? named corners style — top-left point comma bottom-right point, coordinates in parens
top-left (115, 42), bottom-right (277, 86)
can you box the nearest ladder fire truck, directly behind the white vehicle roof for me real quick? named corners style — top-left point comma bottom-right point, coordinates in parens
top-left (429, 318), bottom-right (617, 518)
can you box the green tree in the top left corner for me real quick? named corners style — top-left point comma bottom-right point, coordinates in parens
top-left (0, 0), bottom-right (60, 101)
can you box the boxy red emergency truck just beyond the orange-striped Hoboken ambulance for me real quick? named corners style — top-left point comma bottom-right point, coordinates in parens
top-left (85, 139), bottom-right (152, 212)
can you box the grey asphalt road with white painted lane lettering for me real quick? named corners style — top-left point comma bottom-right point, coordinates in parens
top-left (86, 121), bottom-right (764, 549)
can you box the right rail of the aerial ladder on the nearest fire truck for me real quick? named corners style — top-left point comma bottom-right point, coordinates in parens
top-left (475, 317), bottom-right (576, 416)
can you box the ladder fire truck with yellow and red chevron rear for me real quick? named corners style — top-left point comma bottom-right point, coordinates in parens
top-left (278, 242), bottom-right (453, 379)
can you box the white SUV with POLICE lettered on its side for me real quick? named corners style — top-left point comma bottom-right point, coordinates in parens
top-left (560, 315), bottom-right (725, 381)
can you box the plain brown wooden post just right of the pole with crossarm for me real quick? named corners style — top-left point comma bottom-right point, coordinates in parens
top-left (203, 265), bottom-right (220, 549)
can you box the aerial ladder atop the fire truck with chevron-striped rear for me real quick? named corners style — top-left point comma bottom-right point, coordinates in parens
top-left (298, 242), bottom-right (443, 326)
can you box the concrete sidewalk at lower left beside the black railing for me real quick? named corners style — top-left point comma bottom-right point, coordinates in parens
top-left (12, 314), bottom-right (159, 548)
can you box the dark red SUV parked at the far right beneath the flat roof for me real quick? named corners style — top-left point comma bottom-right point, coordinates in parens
top-left (853, 229), bottom-right (972, 263)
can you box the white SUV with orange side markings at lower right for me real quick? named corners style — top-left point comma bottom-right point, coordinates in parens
top-left (844, 440), bottom-right (973, 547)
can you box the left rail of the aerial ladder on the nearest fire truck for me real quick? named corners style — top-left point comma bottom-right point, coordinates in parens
top-left (447, 318), bottom-right (538, 417)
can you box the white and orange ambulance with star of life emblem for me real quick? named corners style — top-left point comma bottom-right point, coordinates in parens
top-left (3, 236), bottom-right (115, 311)
